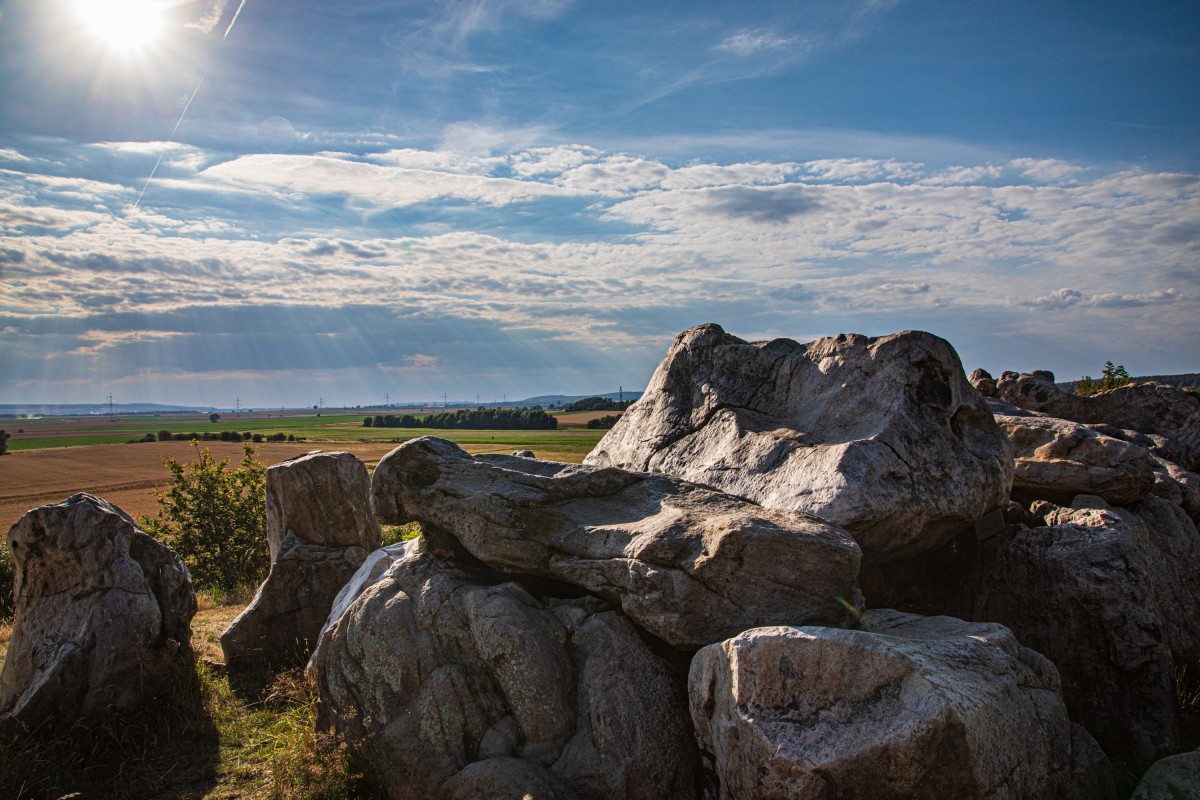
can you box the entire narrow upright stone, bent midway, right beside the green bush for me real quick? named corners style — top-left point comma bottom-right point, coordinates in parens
top-left (221, 452), bottom-right (380, 688)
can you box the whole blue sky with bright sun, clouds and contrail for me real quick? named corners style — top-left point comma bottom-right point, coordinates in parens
top-left (0, 0), bottom-right (1200, 408)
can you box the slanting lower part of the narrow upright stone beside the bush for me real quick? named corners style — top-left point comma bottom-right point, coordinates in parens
top-left (221, 533), bottom-right (367, 681)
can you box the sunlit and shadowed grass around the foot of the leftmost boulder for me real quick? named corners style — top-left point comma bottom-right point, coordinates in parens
top-left (0, 595), bottom-right (378, 800)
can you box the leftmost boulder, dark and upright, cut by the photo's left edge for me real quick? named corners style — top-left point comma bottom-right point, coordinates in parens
top-left (0, 494), bottom-right (196, 735)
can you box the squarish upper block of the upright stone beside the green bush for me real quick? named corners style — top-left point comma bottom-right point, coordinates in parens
top-left (266, 451), bottom-right (380, 564)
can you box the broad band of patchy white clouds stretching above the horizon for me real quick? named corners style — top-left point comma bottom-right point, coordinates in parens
top-left (0, 137), bottom-right (1200, 402)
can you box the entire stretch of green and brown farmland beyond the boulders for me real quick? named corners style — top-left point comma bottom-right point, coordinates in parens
top-left (0, 413), bottom-right (604, 531)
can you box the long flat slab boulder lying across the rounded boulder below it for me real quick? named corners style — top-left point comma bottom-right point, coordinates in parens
top-left (372, 437), bottom-right (862, 648)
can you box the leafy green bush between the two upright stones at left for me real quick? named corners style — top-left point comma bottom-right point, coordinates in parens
top-left (138, 441), bottom-right (270, 593)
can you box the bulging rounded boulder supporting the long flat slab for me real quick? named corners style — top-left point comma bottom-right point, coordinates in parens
top-left (310, 537), bottom-right (698, 800)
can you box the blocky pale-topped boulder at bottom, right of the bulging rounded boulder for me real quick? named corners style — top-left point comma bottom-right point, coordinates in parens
top-left (689, 610), bottom-right (1072, 800)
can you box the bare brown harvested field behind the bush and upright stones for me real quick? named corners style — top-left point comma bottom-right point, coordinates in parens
top-left (0, 441), bottom-right (405, 533)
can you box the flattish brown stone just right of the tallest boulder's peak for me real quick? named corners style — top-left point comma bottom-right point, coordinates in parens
top-left (996, 414), bottom-right (1156, 504)
